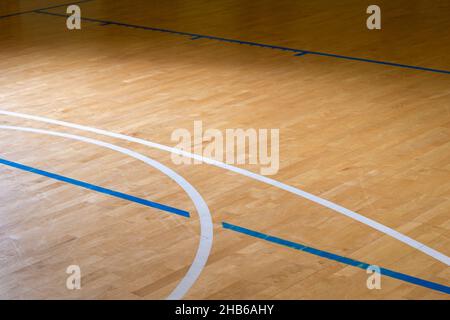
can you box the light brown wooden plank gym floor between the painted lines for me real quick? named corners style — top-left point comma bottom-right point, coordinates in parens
top-left (0, 0), bottom-right (450, 299)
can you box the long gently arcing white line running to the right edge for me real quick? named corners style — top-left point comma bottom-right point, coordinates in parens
top-left (0, 110), bottom-right (450, 266)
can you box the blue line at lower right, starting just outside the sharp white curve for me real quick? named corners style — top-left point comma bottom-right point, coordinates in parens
top-left (222, 222), bottom-right (450, 294)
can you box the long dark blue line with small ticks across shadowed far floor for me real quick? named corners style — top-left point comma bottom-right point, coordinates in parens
top-left (34, 9), bottom-right (450, 74)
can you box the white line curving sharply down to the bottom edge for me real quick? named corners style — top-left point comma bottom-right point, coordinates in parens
top-left (0, 125), bottom-right (213, 300)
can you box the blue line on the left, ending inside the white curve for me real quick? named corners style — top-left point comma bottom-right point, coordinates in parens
top-left (0, 158), bottom-right (190, 218)
